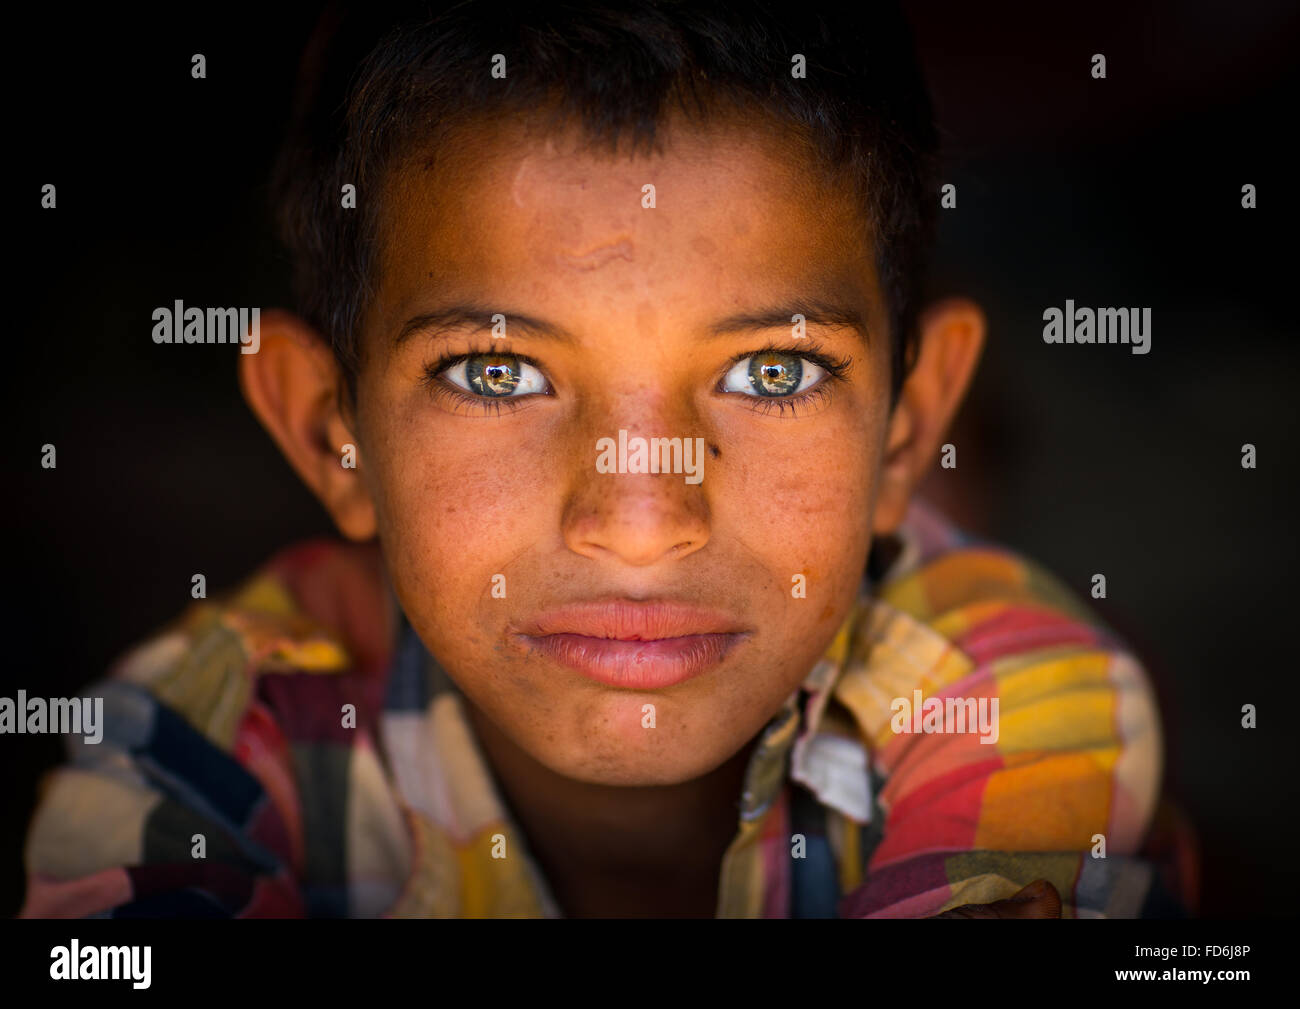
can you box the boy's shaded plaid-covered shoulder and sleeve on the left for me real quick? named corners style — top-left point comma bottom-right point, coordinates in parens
top-left (23, 541), bottom-right (386, 915)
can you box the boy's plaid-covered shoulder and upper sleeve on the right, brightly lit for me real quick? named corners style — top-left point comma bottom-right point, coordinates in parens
top-left (836, 505), bottom-right (1180, 917)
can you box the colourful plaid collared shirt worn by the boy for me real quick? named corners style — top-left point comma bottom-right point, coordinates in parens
top-left (21, 503), bottom-right (1188, 917)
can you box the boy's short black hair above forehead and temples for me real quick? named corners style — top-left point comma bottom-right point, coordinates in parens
top-left (272, 0), bottom-right (937, 398)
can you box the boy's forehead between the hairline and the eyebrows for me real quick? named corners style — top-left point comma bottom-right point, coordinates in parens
top-left (372, 117), bottom-right (881, 332)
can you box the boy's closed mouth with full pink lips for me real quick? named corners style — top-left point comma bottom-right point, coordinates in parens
top-left (515, 599), bottom-right (750, 690)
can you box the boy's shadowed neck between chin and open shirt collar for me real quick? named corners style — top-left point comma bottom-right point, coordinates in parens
top-left (464, 698), bottom-right (755, 917)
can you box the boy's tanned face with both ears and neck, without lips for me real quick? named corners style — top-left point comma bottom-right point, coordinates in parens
top-left (241, 110), bottom-right (984, 914)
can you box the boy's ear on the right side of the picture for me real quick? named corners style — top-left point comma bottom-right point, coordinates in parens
top-left (872, 298), bottom-right (985, 536)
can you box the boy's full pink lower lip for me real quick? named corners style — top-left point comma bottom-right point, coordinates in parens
top-left (524, 635), bottom-right (745, 690)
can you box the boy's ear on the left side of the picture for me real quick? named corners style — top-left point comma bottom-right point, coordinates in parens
top-left (239, 309), bottom-right (376, 540)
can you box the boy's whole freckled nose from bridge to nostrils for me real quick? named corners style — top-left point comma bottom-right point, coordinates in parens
top-left (563, 381), bottom-right (709, 567)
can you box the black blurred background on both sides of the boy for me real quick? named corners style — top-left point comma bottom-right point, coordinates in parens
top-left (10, 3), bottom-right (1300, 917)
